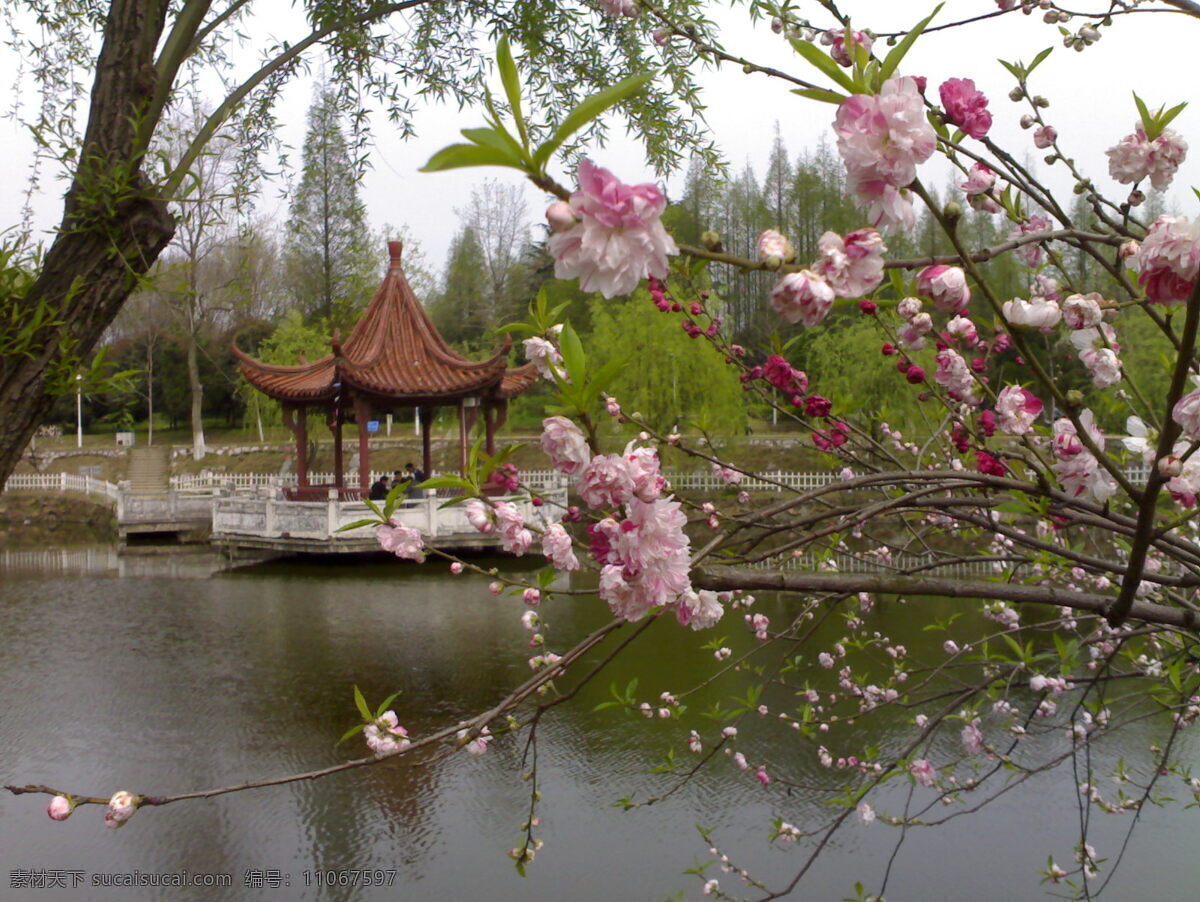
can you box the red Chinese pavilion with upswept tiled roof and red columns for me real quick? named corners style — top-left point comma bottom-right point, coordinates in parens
top-left (233, 241), bottom-right (538, 499)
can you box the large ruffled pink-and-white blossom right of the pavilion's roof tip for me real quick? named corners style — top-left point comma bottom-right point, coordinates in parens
top-left (547, 160), bottom-right (678, 297)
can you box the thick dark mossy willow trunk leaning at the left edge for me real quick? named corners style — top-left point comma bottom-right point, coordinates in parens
top-left (0, 0), bottom-right (175, 481)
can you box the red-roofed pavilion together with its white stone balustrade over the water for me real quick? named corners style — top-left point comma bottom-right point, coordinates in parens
top-left (212, 241), bottom-right (566, 553)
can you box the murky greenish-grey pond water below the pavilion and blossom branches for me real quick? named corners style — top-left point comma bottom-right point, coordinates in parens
top-left (0, 548), bottom-right (1200, 902)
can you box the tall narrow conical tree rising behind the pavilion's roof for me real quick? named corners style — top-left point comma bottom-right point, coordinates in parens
top-left (287, 84), bottom-right (379, 326)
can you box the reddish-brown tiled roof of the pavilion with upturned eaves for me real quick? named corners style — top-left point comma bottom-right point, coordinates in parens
top-left (233, 241), bottom-right (536, 403)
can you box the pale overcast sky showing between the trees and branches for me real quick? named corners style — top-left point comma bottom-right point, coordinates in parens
top-left (0, 0), bottom-right (1200, 280)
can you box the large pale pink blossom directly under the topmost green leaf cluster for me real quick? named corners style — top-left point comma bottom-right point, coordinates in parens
top-left (834, 78), bottom-right (937, 194)
